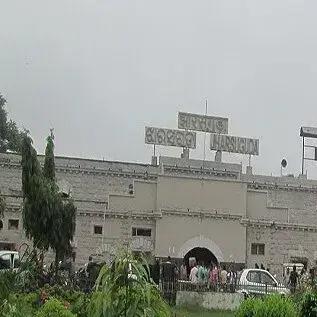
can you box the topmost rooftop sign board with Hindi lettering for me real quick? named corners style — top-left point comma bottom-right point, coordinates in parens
top-left (178, 112), bottom-right (228, 134)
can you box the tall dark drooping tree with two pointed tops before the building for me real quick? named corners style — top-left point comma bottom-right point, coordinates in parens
top-left (22, 134), bottom-right (76, 267)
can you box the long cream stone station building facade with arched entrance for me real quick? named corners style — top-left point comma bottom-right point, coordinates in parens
top-left (0, 154), bottom-right (317, 276)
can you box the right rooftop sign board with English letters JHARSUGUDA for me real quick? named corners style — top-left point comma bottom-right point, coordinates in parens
top-left (210, 134), bottom-right (259, 155)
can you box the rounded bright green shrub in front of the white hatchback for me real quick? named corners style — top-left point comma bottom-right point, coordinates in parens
top-left (236, 295), bottom-right (298, 317)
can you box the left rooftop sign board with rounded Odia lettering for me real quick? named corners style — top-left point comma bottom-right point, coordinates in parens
top-left (145, 127), bottom-right (196, 149)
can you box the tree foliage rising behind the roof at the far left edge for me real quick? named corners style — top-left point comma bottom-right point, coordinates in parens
top-left (0, 94), bottom-right (23, 153)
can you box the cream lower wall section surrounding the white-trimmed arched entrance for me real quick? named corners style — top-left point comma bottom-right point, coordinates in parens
top-left (155, 215), bottom-right (246, 263)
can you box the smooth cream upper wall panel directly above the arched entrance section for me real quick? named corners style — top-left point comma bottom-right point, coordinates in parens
top-left (157, 176), bottom-right (247, 216)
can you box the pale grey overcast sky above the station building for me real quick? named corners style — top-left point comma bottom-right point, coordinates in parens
top-left (0, 0), bottom-right (317, 177)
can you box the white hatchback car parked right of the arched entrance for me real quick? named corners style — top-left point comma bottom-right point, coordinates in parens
top-left (236, 269), bottom-right (290, 296)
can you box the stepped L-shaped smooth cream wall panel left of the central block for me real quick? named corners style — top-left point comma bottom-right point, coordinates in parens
top-left (109, 181), bottom-right (157, 211)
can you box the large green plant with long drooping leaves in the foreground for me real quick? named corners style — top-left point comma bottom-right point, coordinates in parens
top-left (90, 253), bottom-right (170, 317)
